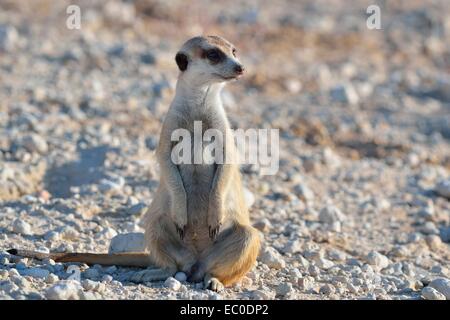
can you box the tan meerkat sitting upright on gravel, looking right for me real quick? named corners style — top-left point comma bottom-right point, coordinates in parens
top-left (10, 36), bottom-right (260, 291)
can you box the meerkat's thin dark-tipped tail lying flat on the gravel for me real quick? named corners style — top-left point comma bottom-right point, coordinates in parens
top-left (7, 249), bottom-right (153, 268)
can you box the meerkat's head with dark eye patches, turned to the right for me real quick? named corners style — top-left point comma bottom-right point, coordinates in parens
top-left (175, 36), bottom-right (244, 84)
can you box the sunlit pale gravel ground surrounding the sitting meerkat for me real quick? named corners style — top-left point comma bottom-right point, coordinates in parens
top-left (0, 0), bottom-right (450, 300)
